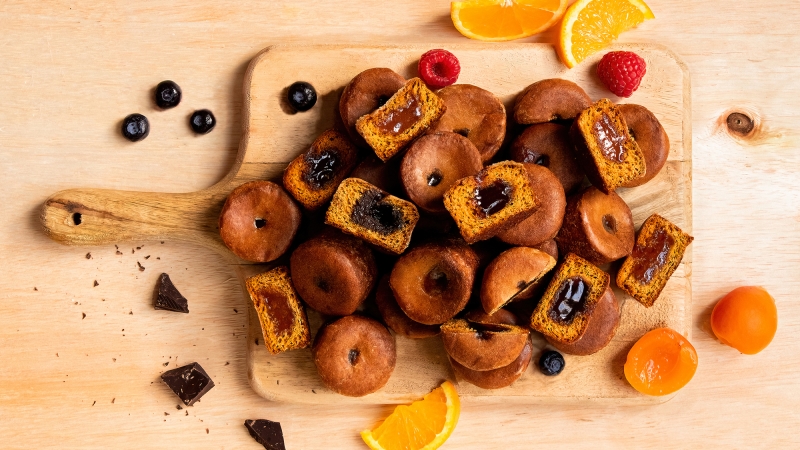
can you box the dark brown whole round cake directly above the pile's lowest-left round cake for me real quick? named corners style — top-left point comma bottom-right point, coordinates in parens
top-left (289, 231), bottom-right (378, 316)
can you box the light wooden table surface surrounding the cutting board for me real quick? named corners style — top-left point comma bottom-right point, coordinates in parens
top-left (0, 0), bottom-right (800, 449)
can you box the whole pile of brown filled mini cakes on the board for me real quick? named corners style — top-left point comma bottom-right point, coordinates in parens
top-left (219, 58), bottom-right (692, 396)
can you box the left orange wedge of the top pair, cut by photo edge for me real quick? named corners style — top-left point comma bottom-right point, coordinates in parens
top-left (450, 0), bottom-right (567, 41)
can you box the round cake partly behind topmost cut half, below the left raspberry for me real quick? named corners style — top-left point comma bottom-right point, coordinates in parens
top-left (428, 84), bottom-right (506, 162)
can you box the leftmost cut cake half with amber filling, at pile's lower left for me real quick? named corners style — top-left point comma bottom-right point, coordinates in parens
top-left (244, 266), bottom-right (311, 355)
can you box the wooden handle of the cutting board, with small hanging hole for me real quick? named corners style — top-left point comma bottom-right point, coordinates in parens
top-left (41, 189), bottom-right (225, 247)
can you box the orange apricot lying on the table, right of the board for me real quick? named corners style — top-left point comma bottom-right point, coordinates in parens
top-left (711, 286), bottom-right (778, 355)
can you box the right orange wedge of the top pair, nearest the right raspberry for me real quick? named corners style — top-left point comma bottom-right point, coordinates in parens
top-left (558, 0), bottom-right (655, 67)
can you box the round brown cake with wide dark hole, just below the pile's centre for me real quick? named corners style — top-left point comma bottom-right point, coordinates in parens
top-left (389, 241), bottom-right (478, 325)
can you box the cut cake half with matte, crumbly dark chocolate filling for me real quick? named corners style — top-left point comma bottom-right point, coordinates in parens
top-left (325, 178), bottom-right (419, 254)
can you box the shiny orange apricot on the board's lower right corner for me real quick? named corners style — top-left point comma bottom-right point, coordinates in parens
top-left (625, 328), bottom-right (697, 395)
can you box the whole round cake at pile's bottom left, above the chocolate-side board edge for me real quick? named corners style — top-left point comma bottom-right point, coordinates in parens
top-left (311, 316), bottom-right (397, 397)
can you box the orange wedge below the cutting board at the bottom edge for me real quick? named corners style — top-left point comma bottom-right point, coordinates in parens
top-left (361, 381), bottom-right (461, 450)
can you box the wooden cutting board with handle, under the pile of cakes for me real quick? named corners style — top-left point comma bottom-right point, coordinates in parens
top-left (41, 43), bottom-right (692, 403)
